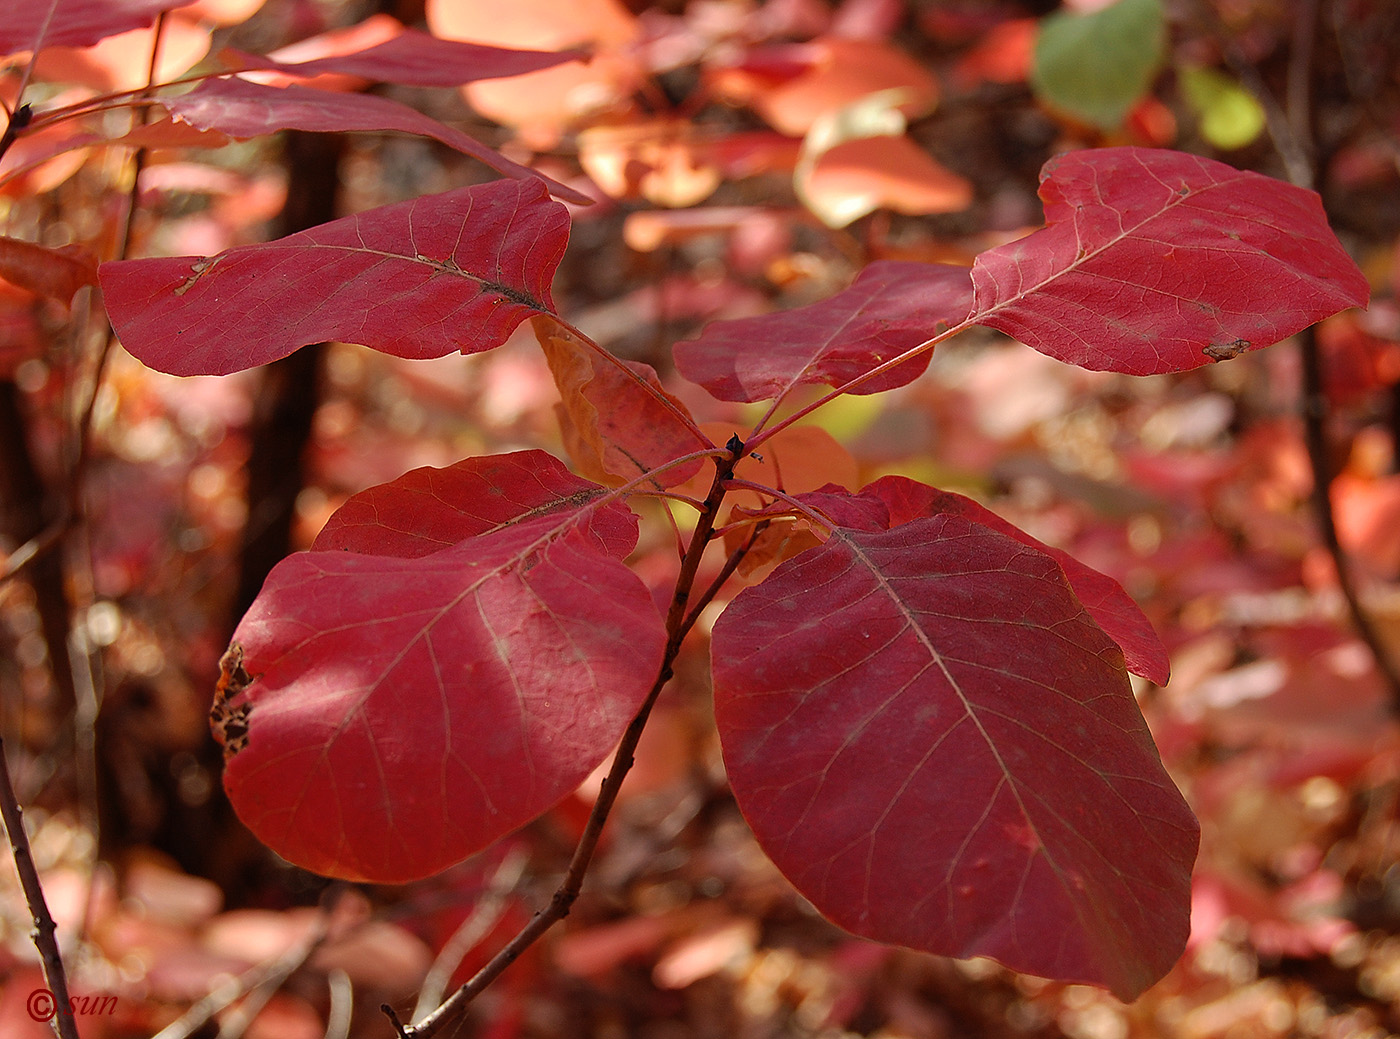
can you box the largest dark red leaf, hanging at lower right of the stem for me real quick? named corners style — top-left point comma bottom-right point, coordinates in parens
top-left (713, 515), bottom-right (1197, 998)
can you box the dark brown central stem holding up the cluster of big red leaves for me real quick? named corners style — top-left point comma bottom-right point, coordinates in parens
top-left (382, 437), bottom-right (743, 1039)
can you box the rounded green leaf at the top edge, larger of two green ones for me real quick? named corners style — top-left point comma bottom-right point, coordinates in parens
top-left (1030, 0), bottom-right (1166, 130)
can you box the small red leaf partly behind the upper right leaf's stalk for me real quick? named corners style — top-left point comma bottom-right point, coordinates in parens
top-left (675, 260), bottom-right (972, 402)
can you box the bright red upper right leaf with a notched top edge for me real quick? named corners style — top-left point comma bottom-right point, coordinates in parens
top-left (972, 148), bottom-right (1369, 375)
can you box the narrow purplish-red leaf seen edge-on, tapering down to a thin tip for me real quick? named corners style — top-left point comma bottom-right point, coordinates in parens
top-left (160, 77), bottom-right (592, 206)
